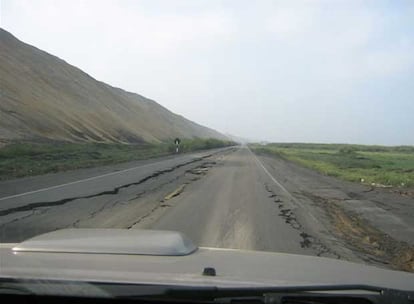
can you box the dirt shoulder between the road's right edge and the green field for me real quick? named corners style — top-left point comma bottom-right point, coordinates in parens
top-left (259, 155), bottom-right (414, 272)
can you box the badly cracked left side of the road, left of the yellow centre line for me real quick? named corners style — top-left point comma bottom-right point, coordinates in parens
top-left (0, 148), bottom-right (234, 242)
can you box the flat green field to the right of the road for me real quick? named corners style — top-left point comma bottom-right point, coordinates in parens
top-left (251, 143), bottom-right (414, 187)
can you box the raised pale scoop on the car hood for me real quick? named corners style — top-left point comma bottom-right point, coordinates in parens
top-left (13, 229), bottom-right (197, 256)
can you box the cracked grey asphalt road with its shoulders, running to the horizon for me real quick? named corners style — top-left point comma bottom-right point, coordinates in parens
top-left (0, 147), bottom-right (414, 268)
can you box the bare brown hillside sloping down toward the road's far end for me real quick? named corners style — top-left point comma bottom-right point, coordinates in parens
top-left (0, 29), bottom-right (225, 144)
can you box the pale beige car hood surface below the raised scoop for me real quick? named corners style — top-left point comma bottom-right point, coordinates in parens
top-left (0, 230), bottom-right (414, 290)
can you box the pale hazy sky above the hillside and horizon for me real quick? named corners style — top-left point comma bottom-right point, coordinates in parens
top-left (0, 0), bottom-right (414, 144)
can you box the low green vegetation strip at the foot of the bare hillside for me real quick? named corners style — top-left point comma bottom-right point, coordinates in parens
top-left (0, 138), bottom-right (234, 180)
